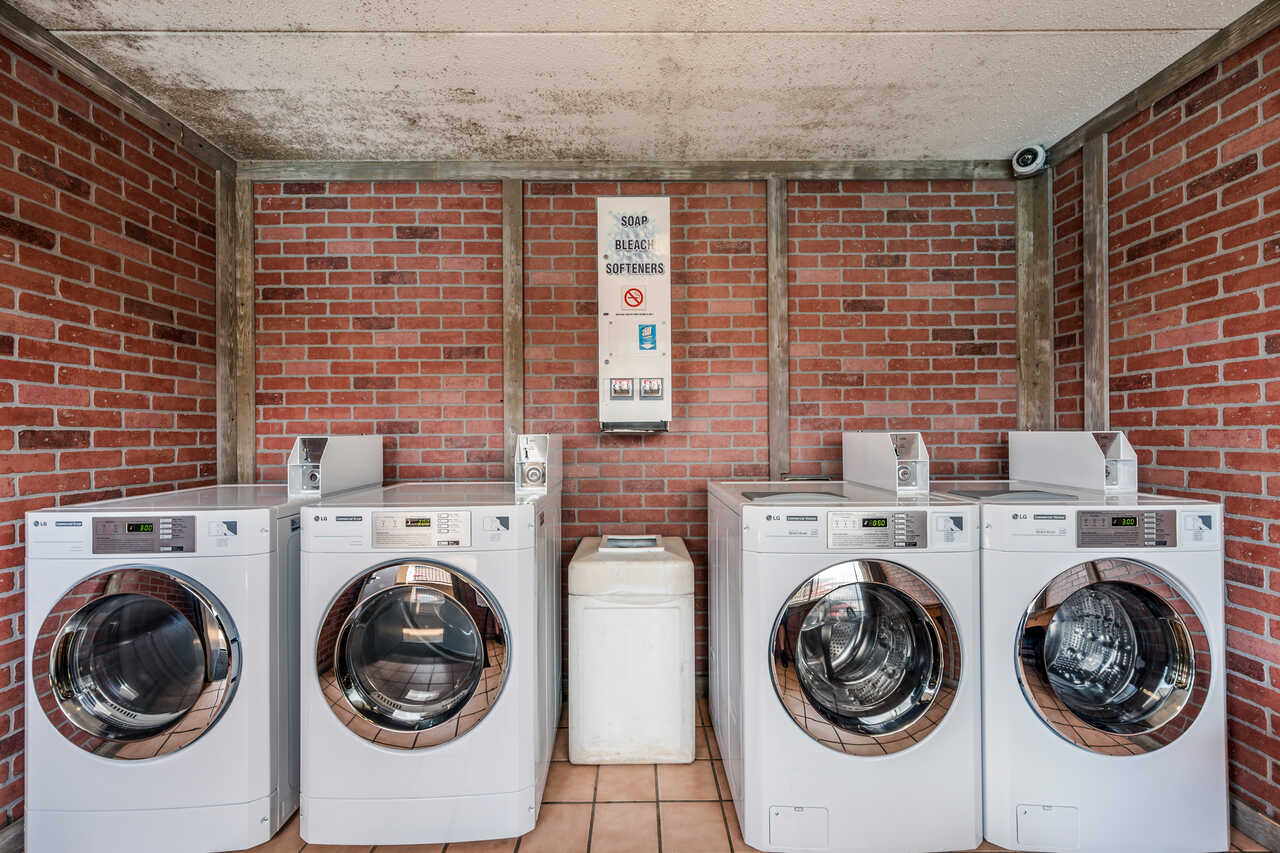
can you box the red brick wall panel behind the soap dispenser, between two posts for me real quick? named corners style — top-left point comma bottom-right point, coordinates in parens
top-left (525, 182), bottom-right (768, 672)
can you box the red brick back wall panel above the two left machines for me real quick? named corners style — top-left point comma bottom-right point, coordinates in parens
top-left (255, 181), bottom-right (506, 480)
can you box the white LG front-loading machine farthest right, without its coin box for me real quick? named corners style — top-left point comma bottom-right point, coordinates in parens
top-left (934, 482), bottom-right (1230, 853)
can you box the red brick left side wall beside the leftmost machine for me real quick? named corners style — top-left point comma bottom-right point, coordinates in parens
top-left (0, 34), bottom-right (215, 822)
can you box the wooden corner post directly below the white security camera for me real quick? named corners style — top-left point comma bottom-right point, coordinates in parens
top-left (1016, 170), bottom-right (1053, 429)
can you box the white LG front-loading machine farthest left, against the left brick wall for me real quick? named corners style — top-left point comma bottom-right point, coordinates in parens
top-left (26, 485), bottom-right (301, 853)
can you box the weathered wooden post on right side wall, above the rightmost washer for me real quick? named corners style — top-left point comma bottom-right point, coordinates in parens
top-left (1082, 133), bottom-right (1111, 430)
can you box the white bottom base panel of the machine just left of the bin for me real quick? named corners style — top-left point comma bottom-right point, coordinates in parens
top-left (300, 786), bottom-right (538, 845)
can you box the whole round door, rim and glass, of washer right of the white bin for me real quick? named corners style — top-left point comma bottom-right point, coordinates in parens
top-left (771, 560), bottom-right (960, 756)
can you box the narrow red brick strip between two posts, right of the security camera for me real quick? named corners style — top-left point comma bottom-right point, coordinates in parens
top-left (1053, 152), bottom-right (1084, 429)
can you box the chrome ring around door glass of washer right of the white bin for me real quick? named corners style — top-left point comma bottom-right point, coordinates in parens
top-left (769, 560), bottom-right (963, 756)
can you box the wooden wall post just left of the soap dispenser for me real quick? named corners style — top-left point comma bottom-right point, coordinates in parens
top-left (502, 178), bottom-right (525, 468)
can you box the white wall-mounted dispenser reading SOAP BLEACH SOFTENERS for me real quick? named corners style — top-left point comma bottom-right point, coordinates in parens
top-left (595, 197), bottom-right (671, 432)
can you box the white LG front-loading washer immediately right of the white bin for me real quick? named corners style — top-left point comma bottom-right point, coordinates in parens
top-left (708, 482), bottom-right (982, 853)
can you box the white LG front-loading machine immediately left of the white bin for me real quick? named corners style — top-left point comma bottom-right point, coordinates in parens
top-left (301, 483), bottom-right (561, 844)
